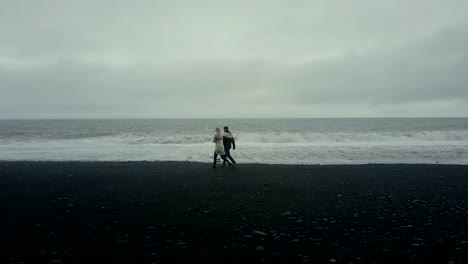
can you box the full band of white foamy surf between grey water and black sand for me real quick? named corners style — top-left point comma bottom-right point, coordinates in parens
top-left (0, 131), bottom-right (468, 164)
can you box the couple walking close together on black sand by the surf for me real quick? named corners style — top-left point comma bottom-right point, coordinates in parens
top-left (213, 126), bottom-right (237, 169)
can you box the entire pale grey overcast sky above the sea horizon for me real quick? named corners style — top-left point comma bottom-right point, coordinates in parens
top-left (0, 0), bottom-right (468, 118)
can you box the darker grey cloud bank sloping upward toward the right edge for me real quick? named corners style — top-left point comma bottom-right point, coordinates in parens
top-left (287, 27), bottom-right (468, 103)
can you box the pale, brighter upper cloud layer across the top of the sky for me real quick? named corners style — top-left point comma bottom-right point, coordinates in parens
top-left (0, 0), bottom-right (468, 60)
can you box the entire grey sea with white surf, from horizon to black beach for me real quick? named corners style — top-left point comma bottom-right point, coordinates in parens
top-left (0, 118), bottom-right (468, 164)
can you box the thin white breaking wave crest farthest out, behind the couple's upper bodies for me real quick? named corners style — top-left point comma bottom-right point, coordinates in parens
top-left (9, 130), bottom-right (462, 145)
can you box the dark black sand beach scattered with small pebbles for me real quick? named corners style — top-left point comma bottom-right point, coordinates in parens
top-left (0, 162), bottom-right (468, 263)
